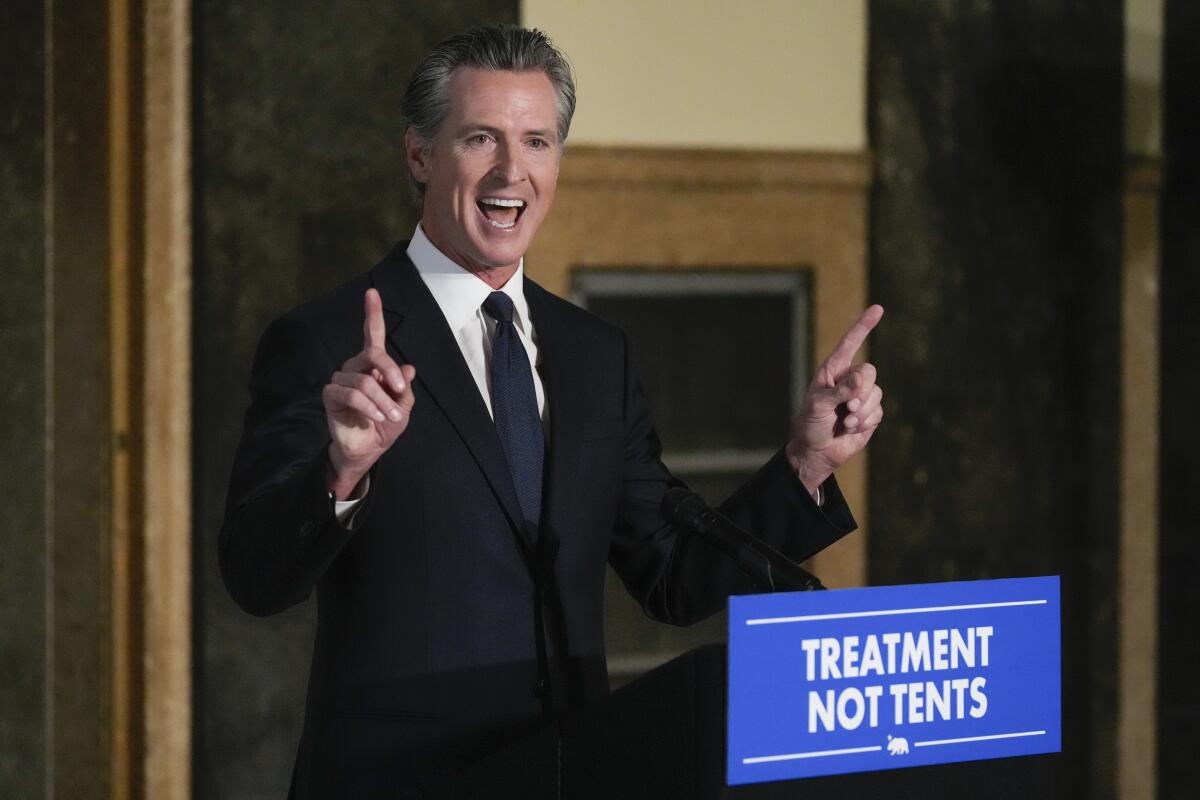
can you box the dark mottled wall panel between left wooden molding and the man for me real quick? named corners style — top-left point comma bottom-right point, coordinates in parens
top-left (194, 0), bottom-right (518, 799)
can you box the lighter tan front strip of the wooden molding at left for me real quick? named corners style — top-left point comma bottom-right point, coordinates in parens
top-left (143, 0), bottom-right (192, 800)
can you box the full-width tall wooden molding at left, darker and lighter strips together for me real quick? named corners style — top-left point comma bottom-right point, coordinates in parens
top-left (109, 0), bottom-right (192, 800)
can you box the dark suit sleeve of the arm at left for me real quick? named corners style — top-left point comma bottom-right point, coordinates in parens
top-left (218, 317), bottom-right (371, 615)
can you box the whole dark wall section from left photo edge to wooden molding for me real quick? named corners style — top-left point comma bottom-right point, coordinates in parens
top-left (0, 0), bottom-right (113, 799)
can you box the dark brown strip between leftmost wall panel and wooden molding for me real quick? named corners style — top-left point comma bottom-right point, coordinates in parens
top-left (46, 0), bottom-right (113, 799)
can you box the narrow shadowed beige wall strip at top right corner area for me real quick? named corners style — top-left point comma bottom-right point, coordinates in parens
top-left (1124, 0), bottom-right (1163, 156)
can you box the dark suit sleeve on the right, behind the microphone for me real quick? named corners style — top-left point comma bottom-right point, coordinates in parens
top-left (608, 331), bottom-right (857, 625)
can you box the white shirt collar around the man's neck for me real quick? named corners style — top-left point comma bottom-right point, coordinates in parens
top-left (408, 223), bottom-right (529, 333)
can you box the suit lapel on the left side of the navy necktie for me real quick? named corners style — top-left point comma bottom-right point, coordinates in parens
top-left (371, 242), bottom-right (532, 558)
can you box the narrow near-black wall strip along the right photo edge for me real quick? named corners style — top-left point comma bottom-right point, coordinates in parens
top-left (1158, 0), bottom-right (1200, 800)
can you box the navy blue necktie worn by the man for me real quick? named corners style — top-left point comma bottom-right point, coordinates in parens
top-left (484, 291), bottom-right (546, 534)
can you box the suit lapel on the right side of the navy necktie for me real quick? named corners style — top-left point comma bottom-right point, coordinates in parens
top-left (524, 276), bottom-right (584, 546)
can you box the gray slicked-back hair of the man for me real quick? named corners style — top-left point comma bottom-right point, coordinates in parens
top-left (401, 24), bottom-right (575, 198)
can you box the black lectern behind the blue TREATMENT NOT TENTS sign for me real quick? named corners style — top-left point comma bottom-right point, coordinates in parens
top-left (426, 645), bottom-right (1058, 800)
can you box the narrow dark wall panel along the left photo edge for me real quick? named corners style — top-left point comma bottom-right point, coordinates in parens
top-left (0, 0), bottom-right (46, 798)
